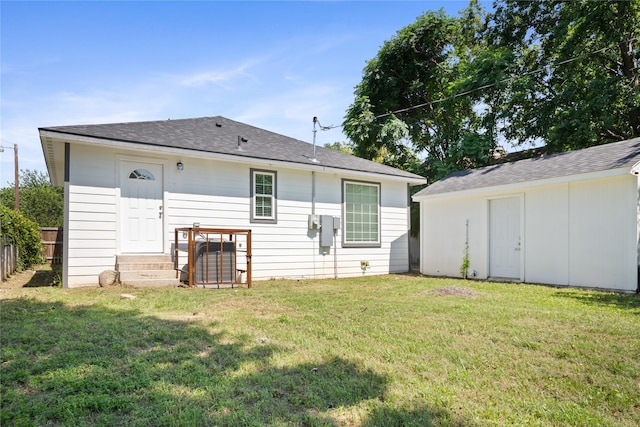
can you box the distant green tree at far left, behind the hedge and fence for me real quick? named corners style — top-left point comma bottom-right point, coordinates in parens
top-left (0, 169), bottom-right (64, 227)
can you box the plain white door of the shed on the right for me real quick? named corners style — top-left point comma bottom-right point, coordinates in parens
top-left (489, 197), bottom-right (522, 280)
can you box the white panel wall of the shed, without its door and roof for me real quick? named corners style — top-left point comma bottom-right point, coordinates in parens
top-left (420, 174), bottom-right (640, 291)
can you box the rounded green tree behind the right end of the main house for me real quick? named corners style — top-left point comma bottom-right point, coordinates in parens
top-left (344, 3), bottom-right (495, 180)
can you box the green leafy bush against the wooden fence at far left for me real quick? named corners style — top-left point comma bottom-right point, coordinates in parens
top-left (0, 206), bottom-right (44, 271)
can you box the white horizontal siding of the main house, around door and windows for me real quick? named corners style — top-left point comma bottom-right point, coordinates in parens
top-left (66, 145), bottom-right (416, 286)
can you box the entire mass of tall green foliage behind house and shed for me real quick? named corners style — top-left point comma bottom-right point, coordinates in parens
top-left (344, 0), bottom-right (640, 181)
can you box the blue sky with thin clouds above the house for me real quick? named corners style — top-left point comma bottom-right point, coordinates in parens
top-left (0, 0), bottom-right (480, 187)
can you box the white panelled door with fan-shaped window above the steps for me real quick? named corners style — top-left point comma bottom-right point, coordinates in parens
top-left (120, 160), bottom-right (163, 253)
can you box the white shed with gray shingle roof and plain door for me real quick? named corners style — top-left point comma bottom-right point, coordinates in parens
top-left (414, 138), bottom-right (640, 292)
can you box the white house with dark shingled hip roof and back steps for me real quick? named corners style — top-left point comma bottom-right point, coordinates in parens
top-left (39, 116), bottom-right (424, 287)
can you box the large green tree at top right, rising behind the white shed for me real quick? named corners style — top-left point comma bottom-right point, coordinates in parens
top-left (479, 0), bottom-right (640, 152)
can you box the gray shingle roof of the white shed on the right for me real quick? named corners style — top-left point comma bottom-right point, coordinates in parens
top-left (415, 138), bottom-right (640, 197)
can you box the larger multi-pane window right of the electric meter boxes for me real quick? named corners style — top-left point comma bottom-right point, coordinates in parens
top-left (342, 180), bottom-right (380, 247)
